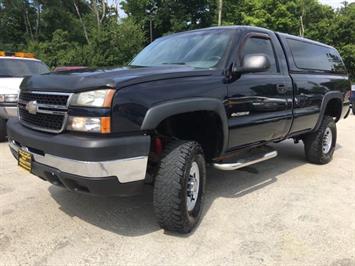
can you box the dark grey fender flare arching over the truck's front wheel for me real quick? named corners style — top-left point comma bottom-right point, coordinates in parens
top-left (141, 98), bottom-right (229, 152)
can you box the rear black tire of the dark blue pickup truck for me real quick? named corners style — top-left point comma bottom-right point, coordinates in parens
top-left (303, 116), bottom-right (337, 164)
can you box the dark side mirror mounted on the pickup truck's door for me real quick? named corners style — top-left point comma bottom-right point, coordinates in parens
top-left (234, 54), bottom-right (271, 74)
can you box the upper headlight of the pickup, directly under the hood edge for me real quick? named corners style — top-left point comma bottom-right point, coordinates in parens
top-left (70, 89), bottom-right (115, 107)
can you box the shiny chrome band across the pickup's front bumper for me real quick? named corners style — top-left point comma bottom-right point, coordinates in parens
top-left (9, 141), bottom-right (148, 183)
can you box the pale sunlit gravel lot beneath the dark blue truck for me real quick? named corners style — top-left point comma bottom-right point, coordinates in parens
top-left (0, 116), bottom-right (355, 266)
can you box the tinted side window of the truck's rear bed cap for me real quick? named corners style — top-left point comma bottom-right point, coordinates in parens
top-left (287, 39), bottom-right (345, 73)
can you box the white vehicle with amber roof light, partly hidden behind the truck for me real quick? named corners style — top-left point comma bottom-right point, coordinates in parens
top-left (0, 51), bottom-right (49, 142)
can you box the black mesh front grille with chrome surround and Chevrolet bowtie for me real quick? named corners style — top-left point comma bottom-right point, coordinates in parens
top-left (18, 92), bottom-right (70, 133)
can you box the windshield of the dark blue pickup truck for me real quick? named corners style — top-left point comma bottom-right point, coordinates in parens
top-left (130, 30), bottom-right (232, 68)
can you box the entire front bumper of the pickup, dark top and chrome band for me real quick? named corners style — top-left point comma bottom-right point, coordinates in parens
top-left (8, 119), bottom-right (150, 195)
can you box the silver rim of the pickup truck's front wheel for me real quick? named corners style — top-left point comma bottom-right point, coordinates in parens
top-left (186, 162), bottom-right (200, 212)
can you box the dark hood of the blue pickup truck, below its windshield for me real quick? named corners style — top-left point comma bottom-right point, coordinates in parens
top-left (21, 66), bottom-right (214, 93)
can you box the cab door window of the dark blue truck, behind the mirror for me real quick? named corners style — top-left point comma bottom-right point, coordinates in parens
top-left (242, 37), bottom-right (278, 73)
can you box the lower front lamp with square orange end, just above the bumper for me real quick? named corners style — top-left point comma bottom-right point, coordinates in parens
top-left (67, 116), bottom-right (111, 133)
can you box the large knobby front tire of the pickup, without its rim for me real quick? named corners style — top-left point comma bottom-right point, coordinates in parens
top-left (153, 140), bottom-right (206, 234)
